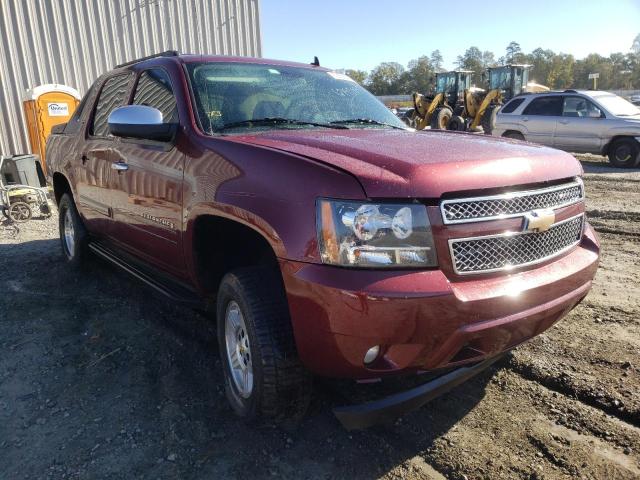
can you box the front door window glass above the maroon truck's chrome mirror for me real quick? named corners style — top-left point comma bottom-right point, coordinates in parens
top-left (133, 68), bottom-right (178, 123)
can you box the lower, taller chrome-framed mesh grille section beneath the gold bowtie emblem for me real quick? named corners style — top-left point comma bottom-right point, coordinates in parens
top-left (449, 215), bottom-right (584, 275)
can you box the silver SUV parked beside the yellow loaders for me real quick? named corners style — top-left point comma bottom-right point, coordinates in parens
top-left (493, 90), bottom-right (640, 168)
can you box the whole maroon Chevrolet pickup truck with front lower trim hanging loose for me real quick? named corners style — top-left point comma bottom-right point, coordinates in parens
top-left (47, 52), bottom-right (599, 428)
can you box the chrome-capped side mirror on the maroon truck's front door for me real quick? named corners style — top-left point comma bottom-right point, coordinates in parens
top-left (108, 105), bottom-right (178, 142)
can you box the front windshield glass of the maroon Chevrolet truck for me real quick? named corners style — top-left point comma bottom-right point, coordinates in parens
top-left (187, 63), bottom-right (406, 134)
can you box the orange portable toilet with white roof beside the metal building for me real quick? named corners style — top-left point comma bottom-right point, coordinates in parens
top-left (23, 84), bottom-right (80, 173)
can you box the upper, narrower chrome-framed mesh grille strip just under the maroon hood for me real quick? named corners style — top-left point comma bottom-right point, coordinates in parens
top-left (440, 180), bottom-right (584, 223)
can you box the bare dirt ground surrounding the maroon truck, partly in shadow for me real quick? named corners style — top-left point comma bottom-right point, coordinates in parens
top-left (0, 156), bottom-right (640, 479)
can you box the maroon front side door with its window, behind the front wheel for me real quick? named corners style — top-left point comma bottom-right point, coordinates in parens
top-left (111, 67), bottom-right (184, 276)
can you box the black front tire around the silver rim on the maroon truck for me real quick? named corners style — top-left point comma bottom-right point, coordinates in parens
top-left (216, 267), bottom-right (312, 423)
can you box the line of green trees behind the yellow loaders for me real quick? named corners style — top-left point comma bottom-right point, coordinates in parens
top-left (345, 34), bottom-right (640, 95)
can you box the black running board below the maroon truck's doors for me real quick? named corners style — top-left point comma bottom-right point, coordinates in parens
top-left (89, 242), bottom-right (208, 310)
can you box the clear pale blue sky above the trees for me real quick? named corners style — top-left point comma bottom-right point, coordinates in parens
top-left (260, 0), bottom-right (640, 71)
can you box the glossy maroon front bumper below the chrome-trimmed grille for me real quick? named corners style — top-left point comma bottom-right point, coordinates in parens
top-left (280, 226), bottom-right (599, 379)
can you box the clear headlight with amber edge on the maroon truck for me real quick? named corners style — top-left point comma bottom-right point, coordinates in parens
top-left (317, 199), bottom-right (438, 268)
